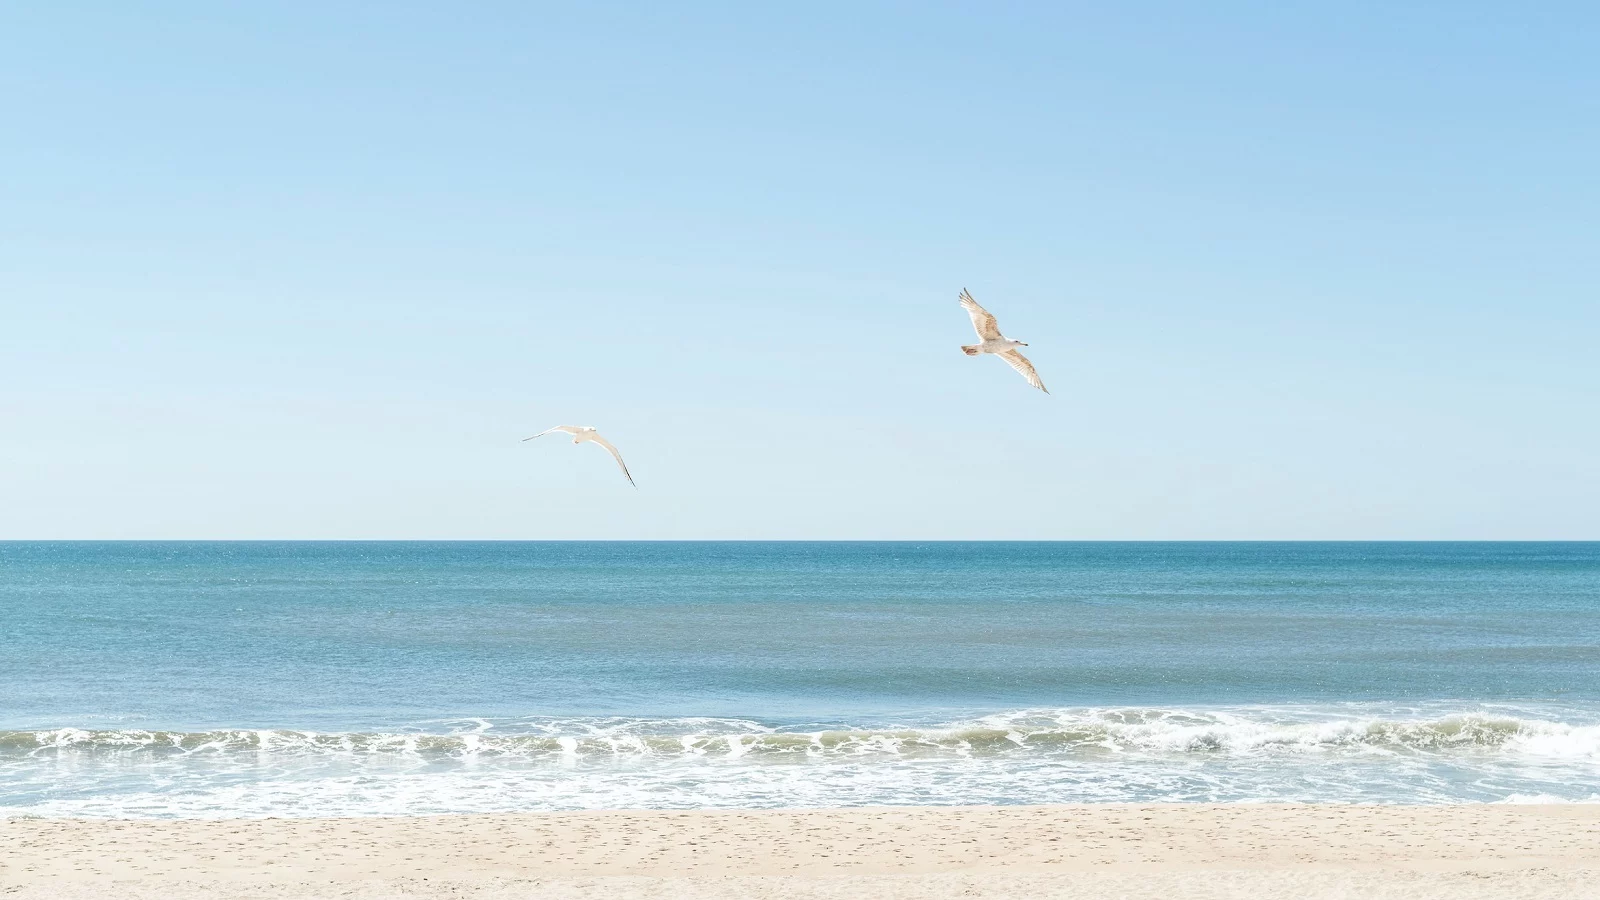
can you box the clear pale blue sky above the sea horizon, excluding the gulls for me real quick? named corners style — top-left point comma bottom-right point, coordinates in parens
top-left (0, 0), bottom-right (1600, 540)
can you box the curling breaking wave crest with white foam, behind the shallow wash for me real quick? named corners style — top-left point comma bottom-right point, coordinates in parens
top-left (12, 709), bottom-right (1600, 759)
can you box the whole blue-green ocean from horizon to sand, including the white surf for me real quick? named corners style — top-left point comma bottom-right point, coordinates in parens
top-left (0, 541), bottom-right (1600, 818)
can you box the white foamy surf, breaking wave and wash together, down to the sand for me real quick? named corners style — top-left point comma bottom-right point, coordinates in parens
top-left (0, 706), bottom-right (1600, 817)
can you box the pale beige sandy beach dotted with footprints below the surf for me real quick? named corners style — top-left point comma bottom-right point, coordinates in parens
top-left (0, 806), bottom-right (1600, 900)
